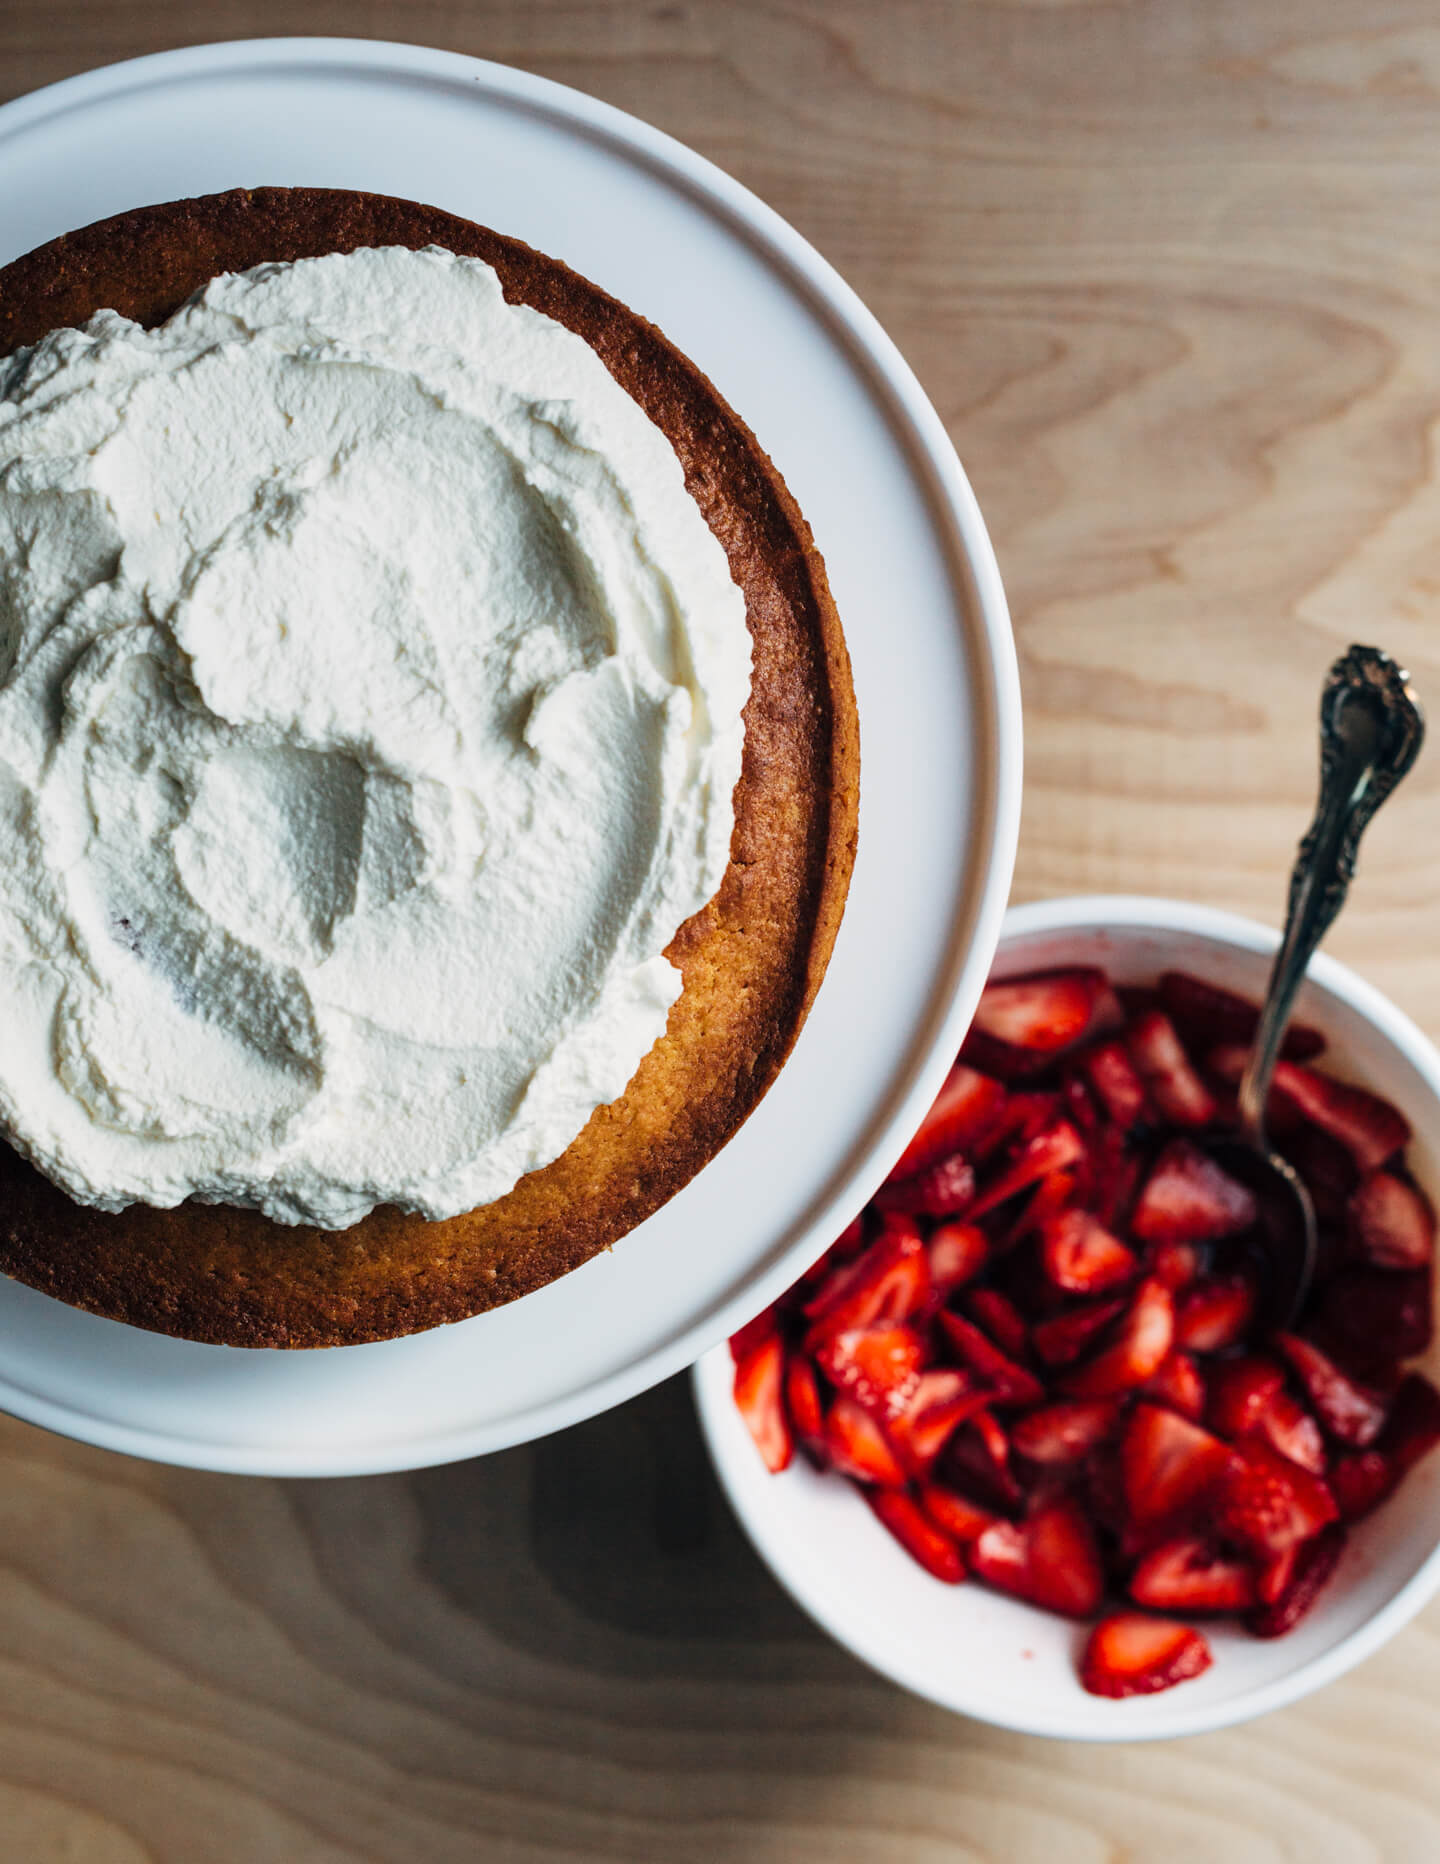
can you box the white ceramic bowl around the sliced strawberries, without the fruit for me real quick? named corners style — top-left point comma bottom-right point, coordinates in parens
top-left (693, 897), bottom-right (1440, 1741)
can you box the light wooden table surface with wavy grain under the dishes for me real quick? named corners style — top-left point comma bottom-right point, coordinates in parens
top-left (0, 0), bottom-right (1440, 1864)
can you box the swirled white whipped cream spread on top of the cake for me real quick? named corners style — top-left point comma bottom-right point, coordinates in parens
top-left (0, 248), bottom-right (751, 1228)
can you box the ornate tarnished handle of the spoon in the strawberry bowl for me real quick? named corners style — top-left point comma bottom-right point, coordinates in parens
top-left (1239, 647), bottom-right (1425, 1137)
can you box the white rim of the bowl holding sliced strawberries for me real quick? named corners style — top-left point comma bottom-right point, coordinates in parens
top-left (691, 893), bottom-right (1440, 1743)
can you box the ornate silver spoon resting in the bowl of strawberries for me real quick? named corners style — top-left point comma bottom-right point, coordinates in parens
top-left (1209, 647), bottom-right (1425, 1329)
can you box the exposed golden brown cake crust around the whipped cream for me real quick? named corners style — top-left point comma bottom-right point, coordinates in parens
top-left (0, 188), bottom-right (859, 1346)
